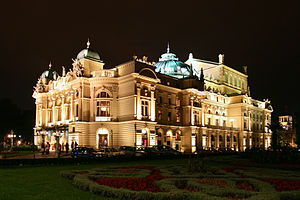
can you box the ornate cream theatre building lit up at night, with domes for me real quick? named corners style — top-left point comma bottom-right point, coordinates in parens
top-left (33, 43), bottom-right (272, 152)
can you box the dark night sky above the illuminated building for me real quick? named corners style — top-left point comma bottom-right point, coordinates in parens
top-left (0, 0), bottom-right (300, 113)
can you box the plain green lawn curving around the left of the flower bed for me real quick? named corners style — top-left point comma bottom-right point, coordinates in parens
top-left (0, 160), bottom-right (182, 200)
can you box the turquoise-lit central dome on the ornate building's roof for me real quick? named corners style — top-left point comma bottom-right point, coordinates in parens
top-left (155, 45), bottom-right (191, 78)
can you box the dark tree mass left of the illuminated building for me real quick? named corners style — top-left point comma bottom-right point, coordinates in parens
top-left (0, 99), bottom-right (35, 142)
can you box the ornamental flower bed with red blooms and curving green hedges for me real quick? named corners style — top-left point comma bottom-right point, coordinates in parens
top-left (61, 166), bottom-right (300, 200)
